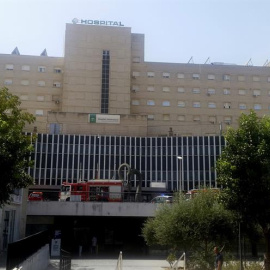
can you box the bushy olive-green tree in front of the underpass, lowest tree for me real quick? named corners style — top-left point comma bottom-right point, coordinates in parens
top-left (142, 190), bottom-right (234, 269)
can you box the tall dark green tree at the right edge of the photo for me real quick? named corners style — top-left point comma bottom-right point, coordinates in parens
top-left (217, 111), bottom-right (270, 270)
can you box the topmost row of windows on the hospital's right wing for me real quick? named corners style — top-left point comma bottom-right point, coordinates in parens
top-left (132, 71), bottom-right (270, 82)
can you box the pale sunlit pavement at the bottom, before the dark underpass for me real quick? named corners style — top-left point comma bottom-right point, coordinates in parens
top-left (47, 259), bottom-right (169, 270)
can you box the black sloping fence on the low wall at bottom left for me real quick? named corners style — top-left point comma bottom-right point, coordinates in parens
top-left (6, 231), bottom-right (50, 270)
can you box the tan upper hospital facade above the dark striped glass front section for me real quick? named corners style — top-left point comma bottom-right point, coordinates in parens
top-left (0, 21), bottom-right (270, 137)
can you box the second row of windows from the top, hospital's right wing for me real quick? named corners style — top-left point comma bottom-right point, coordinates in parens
top-left (131, 85), bottom-right (270, 96)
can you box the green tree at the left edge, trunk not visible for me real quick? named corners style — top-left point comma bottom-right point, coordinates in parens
top-left (0, 88), bottom-right (34, 207)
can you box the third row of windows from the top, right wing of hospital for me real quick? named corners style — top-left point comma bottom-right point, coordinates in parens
top-left (131, 99), bottom-right (264, 110)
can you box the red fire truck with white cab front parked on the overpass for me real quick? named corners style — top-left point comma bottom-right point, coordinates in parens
top-left (59, 180), bottom-right (123, 202)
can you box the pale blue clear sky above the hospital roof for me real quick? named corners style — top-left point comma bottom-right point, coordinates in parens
top-left (0, 0), bottom-right (270, 66)
